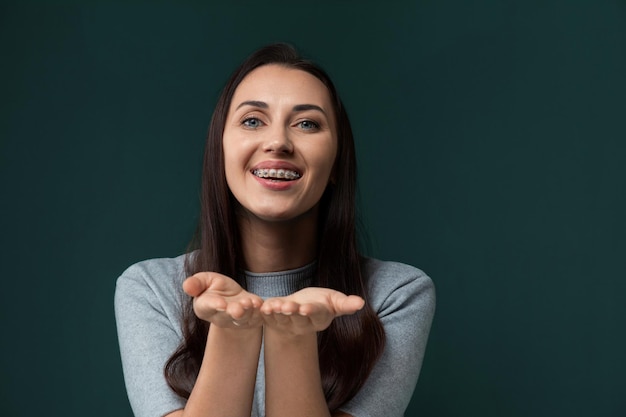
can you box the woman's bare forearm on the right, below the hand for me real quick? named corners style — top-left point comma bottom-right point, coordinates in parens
top-left (265, 326), bottom-right (330, 417)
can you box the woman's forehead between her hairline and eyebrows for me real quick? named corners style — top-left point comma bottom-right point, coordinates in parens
top-left (231, 64), bottom-right (332, 111)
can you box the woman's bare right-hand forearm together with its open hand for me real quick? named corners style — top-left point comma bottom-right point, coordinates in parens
top-left (261, 288), bottom-right (364, 417)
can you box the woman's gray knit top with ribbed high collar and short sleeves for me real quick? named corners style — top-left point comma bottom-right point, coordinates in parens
top-left (115, 255), bottom-right (435, 417)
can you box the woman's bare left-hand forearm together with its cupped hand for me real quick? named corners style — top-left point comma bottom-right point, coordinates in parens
top-left (168, 273), bottom-right (263, 417)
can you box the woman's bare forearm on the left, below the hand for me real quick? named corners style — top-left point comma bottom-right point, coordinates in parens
top-left (183, 326), bottom-right (262, 417)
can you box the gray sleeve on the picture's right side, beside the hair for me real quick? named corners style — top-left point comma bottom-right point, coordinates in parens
top-left (341, 260), bottom-right (435, 417)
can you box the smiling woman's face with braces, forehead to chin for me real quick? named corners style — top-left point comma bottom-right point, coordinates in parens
top-left (223, 65), bottom-right (337, 221)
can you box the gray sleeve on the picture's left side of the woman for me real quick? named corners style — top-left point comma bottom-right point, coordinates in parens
top-left (115, 260), bottom-right (185, 417)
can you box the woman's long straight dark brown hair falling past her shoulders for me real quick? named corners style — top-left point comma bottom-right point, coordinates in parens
top-left (165, 44), bottom-right (385, 411)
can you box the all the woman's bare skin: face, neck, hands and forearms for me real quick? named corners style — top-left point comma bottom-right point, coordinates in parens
top-left (168, 65), bottom-right (364, 417)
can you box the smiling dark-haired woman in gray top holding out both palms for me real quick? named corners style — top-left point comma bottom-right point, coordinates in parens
top-left (115, 44), bottom-right (434, 417)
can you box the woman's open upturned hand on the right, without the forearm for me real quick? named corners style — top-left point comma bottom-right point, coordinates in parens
top-left (260, 287), bottom-right (365, 335)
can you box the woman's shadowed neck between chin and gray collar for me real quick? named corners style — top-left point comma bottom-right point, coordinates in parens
top-left (239, 209), bottom-right (317, 272)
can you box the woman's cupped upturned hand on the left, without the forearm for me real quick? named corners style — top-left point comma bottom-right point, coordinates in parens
top-left (183, 272), bottom-right (263, 329)
